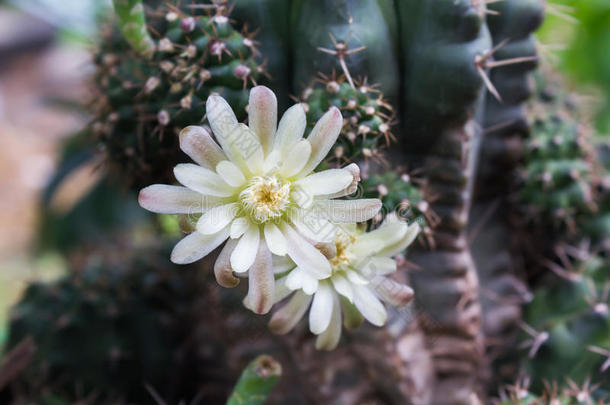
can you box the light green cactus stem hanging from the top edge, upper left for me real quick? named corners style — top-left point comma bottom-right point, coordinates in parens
top-left (112, 0), bottom-right (155, 58)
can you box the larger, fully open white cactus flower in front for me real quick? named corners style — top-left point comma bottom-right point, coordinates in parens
top-left (139, 86), bottom-right (381, 313)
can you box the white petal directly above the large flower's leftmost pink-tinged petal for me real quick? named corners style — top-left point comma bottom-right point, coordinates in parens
top-left (174, 163), bottom-right (235, 197)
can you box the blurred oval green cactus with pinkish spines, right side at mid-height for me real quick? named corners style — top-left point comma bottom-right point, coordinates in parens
top-left (521, 78), bottom-right (596, 232)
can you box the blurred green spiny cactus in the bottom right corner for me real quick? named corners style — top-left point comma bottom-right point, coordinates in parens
top-left (525, 255), bottom-right (610, 395)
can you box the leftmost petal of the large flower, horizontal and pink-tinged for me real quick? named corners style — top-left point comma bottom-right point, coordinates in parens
top-left (138, 184), bottom-right (214, 214)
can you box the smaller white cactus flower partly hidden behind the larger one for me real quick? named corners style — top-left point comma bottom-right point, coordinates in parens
top-left (269, 216), bottom-right (420, 350)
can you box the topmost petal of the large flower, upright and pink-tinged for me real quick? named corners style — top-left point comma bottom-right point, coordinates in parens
top-left (248, 86), bottom-right (277, 153)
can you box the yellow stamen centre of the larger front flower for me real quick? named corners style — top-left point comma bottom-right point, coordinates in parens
top-left (239, 176), bottom-right (290, 223)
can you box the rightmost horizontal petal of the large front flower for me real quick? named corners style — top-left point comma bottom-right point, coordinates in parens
top-left (315, 198), bottom-right (382, 223)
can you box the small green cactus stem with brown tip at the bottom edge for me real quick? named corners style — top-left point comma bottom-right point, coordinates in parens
top-left (227, 354), bottom-right (282, 405)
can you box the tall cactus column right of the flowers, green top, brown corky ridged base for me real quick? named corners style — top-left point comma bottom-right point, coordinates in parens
top-left (397, 0), bottom-right (491, 404)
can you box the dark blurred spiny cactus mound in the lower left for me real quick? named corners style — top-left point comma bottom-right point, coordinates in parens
top-left (9, 249), bottom-right (230, 403)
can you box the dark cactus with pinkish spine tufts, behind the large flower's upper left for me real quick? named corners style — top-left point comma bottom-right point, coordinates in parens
top-left (92, 3), bottom-right (262, 188)
